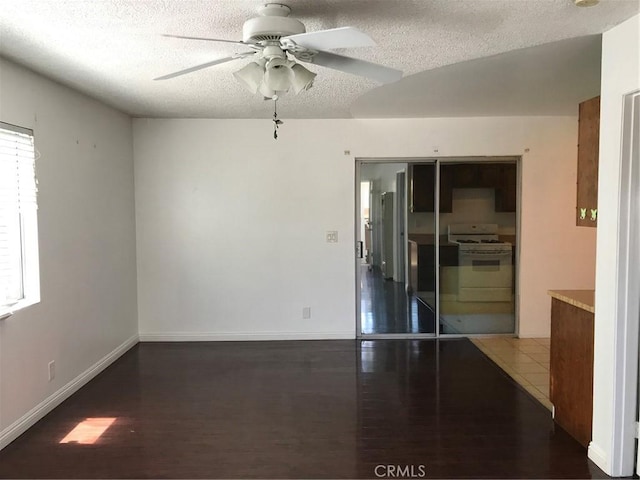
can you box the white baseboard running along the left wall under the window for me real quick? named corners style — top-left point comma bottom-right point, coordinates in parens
top-left (0, 334), bottom-right (139, 450)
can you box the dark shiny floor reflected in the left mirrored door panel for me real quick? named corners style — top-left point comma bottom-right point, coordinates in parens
top-left (360, 266), bottom-right (435, 334)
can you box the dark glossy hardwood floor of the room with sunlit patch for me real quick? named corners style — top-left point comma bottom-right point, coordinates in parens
top-left (0, 339), bottom-right (606, 478)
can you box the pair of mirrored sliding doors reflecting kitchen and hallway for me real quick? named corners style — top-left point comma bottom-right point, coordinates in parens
top-left (356, 157), bottom-right (519, 337)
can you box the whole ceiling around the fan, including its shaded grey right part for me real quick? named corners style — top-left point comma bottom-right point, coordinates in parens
top-left (0, 0), bottom-right (640, 118)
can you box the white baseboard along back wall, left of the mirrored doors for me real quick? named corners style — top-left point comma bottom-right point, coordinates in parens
top-left (140, 331), bottom-right (356, 342)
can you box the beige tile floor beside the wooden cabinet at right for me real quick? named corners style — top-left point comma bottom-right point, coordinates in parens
top-left (472, 337), bottom-right (552, 410)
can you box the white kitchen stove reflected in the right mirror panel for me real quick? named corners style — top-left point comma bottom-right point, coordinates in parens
top-left (448, 223), bottom-right (513, 302)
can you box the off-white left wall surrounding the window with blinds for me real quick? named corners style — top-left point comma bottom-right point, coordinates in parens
top-left (0, 60), bottom-right (138, 448)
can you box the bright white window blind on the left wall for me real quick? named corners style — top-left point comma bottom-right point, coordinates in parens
top-left (0, 122), bottom-right (37, 307)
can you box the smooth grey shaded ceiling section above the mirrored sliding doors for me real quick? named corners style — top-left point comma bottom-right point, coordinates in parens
top-left (351, 35), bottom-right (602, 118)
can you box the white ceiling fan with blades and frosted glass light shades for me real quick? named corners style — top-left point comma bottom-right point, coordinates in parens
top-left (155, 3), bottom-right (402, 100)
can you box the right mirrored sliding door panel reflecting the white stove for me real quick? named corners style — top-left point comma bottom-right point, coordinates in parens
top-left (430, 159), bottom-right (517, 335)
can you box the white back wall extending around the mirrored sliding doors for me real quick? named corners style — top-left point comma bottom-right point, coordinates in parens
top-left (134, 117), bottom-right (595, 340)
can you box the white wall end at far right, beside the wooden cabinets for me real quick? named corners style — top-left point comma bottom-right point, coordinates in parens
top-left (589, 16), bottom-right (640, 476)
